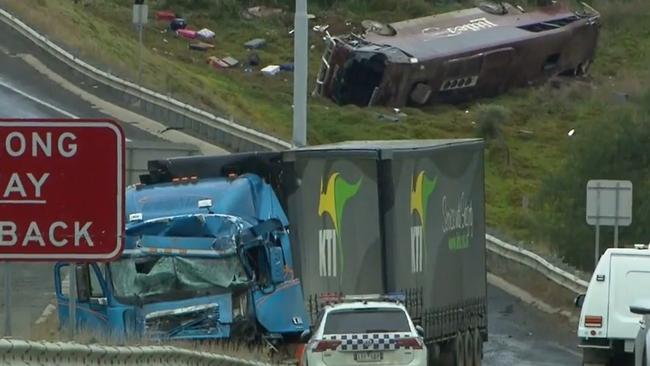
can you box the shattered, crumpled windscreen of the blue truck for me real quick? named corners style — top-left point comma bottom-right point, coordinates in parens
top-left (110, 256), bottom-right (247, 303)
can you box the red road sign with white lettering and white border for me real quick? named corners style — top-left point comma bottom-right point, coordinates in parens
top-left (0, 119), bottom-right (124, 261)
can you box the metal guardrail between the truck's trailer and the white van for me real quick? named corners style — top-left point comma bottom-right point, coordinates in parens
top-left (485, 234), bottom-right (589, 294)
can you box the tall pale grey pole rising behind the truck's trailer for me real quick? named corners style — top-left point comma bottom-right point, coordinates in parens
top-left (293, 0), bottom-right (309, 147)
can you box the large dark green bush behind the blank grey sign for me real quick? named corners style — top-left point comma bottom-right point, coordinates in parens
top-left (536, 93), bottom-right (650, 268)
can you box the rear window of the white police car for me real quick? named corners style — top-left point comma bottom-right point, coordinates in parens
top-left (323, 308), bottom-right (411, 334)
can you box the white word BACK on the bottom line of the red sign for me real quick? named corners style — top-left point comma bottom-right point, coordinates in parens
top-left (0, 221), bottom-right (95, 248)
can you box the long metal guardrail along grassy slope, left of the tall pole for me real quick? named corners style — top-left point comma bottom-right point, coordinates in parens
top-left (0, 9), bottom-right (292, 152)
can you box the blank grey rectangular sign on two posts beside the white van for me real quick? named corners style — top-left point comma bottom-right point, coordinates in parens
top-left (587, 180), bottom-right (632, 268)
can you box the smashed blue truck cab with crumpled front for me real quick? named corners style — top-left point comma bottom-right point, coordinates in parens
top-left (54, 174), bottom-right (309, 341)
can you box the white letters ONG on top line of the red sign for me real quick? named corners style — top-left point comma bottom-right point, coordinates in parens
top-left (4, 131), bottom-right (77, 158)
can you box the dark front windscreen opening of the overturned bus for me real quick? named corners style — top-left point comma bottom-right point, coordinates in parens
top-left (334, 52), bottom-right (386, 107)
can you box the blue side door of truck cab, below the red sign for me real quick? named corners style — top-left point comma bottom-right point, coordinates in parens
top-left (54, 264), bottom-right (108, 333)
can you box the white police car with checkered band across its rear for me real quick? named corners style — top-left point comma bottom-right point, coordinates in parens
top-left (301, 295), bottom-right (427, 366)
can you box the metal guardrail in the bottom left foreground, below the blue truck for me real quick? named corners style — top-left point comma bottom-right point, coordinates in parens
top-left (0, 339), bottom-right (271, 366)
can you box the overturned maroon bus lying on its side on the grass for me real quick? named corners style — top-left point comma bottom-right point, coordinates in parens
top-left (314, 2), bottom-right (600, 107)
